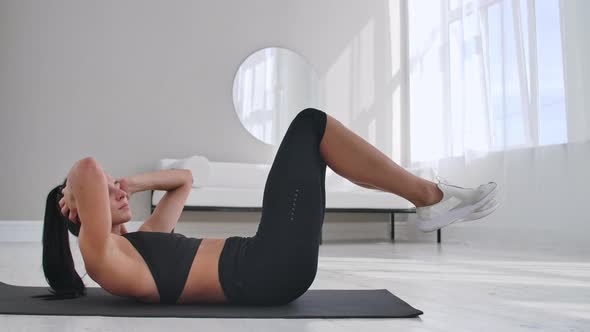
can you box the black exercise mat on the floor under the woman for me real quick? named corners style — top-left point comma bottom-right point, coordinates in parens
top-left (0, 282), bottom-right (422, 318)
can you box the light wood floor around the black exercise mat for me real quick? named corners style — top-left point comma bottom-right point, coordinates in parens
top-left (0, 222), bottom-right (590, 332)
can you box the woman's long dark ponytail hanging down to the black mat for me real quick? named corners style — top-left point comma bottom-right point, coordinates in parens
top-left (33, 178), bottom-right (86, 300)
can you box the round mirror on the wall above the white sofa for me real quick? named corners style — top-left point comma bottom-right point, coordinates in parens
top-left (233, 47), bottom-right (321, 145)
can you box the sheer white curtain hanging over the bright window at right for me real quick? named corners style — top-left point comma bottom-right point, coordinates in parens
top-left (408, 0), bottom-right (590, 239)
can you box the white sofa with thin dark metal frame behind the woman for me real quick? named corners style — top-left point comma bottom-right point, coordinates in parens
top-left (151, 155), bottom-right (440, 242)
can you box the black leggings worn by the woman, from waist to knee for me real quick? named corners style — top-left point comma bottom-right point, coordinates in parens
top-left (219, 108), bottom-right (327, 305)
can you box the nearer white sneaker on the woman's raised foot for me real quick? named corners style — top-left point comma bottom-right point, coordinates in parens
top-left (416, 182), bottom-right (498, 232)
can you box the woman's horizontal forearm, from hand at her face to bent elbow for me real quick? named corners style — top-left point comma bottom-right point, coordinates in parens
top-left (119, 169), bottom-right (193, 196)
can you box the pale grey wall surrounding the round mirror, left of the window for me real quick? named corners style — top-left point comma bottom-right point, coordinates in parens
top-left (0, 0), bottom-right (403, 224)
